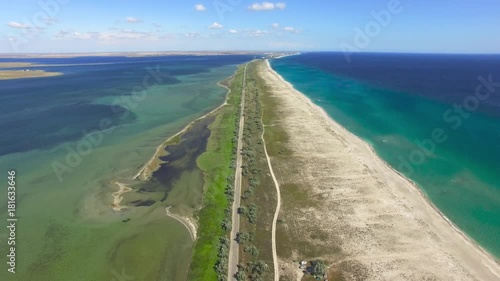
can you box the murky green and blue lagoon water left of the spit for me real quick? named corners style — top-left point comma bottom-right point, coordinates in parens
top-left (0, 53), bottom-right (252, 281)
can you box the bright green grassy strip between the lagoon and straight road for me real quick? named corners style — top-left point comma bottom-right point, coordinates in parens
top-left (188, 64), bottom-right (243, 281)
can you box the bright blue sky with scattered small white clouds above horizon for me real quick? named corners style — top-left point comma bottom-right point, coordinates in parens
top-left (0, 0), bottom-right (500, 53)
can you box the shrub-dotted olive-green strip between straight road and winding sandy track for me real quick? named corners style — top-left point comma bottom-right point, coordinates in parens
top-left (236, 61), bottom-right (276, 281)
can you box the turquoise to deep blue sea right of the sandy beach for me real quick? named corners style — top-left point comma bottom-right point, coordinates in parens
top-left (271, 53), bottom-right (500, 258)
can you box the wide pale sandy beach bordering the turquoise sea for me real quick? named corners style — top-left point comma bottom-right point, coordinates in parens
top-left (262, 61), bottom-right (500, 280)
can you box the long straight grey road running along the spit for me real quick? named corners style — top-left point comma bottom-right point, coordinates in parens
top-left (227, 65), bottom-right (247, 281)
